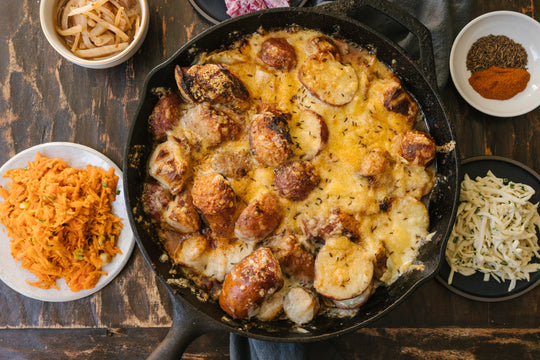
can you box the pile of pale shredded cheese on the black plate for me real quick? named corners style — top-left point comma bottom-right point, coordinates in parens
top-left (446, 171), bottom-right (540, 291)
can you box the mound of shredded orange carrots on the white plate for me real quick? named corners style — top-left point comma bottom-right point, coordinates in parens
top-left (0, 153), bottom-right (122, 292)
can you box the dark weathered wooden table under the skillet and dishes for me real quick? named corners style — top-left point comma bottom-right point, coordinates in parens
top-left (0, 0), bottom-right (540, 359)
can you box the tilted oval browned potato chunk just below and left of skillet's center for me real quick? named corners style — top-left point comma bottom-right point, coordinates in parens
top-left (234, 192), bottom-right (283, 242)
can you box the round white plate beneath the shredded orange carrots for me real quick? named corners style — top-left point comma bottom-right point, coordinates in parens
top-left (0, 142), bottom-right (135, 302)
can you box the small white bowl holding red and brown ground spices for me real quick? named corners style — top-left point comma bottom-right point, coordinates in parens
top-left (450, 11), bottom-right (540, 117)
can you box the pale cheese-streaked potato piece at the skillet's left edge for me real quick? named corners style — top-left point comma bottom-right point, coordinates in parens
top-left (148, 135), bottom-right (191, 195)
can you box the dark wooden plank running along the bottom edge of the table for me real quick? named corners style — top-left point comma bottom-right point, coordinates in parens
top-left (4, 328), bottom-right (540, 360)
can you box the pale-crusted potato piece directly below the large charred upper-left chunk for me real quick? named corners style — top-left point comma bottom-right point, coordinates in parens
top-left (181, 104), bottom-right (241, 147)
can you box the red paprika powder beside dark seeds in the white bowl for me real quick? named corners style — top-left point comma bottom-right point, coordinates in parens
top-left (469, 66), bottom-right (531, 100)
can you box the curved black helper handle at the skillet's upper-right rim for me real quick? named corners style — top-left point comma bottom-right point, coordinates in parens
top-left (317, 0), bottom-right (437, 89)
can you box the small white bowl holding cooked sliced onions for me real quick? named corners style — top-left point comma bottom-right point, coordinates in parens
top-left (39, 0), bottom-right (150, 69)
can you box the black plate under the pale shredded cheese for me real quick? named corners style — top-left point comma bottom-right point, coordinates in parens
top-left (437, 156), bottom-right (540, 302)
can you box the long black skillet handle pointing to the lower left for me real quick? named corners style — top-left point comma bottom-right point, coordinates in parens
top-left (147, 286), bottom-right (215, 360)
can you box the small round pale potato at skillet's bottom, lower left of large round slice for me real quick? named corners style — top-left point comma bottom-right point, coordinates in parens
top-left (283, 286), bottom-right (319, 325)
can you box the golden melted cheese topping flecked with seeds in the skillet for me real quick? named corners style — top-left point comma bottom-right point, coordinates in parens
top-left (156, 30), bottom-right (435, 316)
